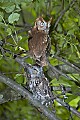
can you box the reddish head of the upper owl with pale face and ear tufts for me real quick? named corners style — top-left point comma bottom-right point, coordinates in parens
top-left (34, 17), bottom-right (52, 33)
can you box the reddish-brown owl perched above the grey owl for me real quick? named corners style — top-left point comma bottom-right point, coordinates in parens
top-left (28, 17), bottom-right (51, 67)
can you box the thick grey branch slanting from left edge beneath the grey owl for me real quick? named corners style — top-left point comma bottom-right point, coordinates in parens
top-left (0, 73), bottom-right (58, 120)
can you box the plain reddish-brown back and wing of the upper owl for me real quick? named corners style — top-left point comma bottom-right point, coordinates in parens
top-left (28, 31), bottom-right (48, 59)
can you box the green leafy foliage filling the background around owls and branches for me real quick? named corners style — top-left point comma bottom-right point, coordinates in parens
top-left (0, 0), bottom-right (80, 120)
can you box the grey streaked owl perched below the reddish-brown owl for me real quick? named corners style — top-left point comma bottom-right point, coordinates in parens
top-left (25, 64), bottom-right (53, 106)
